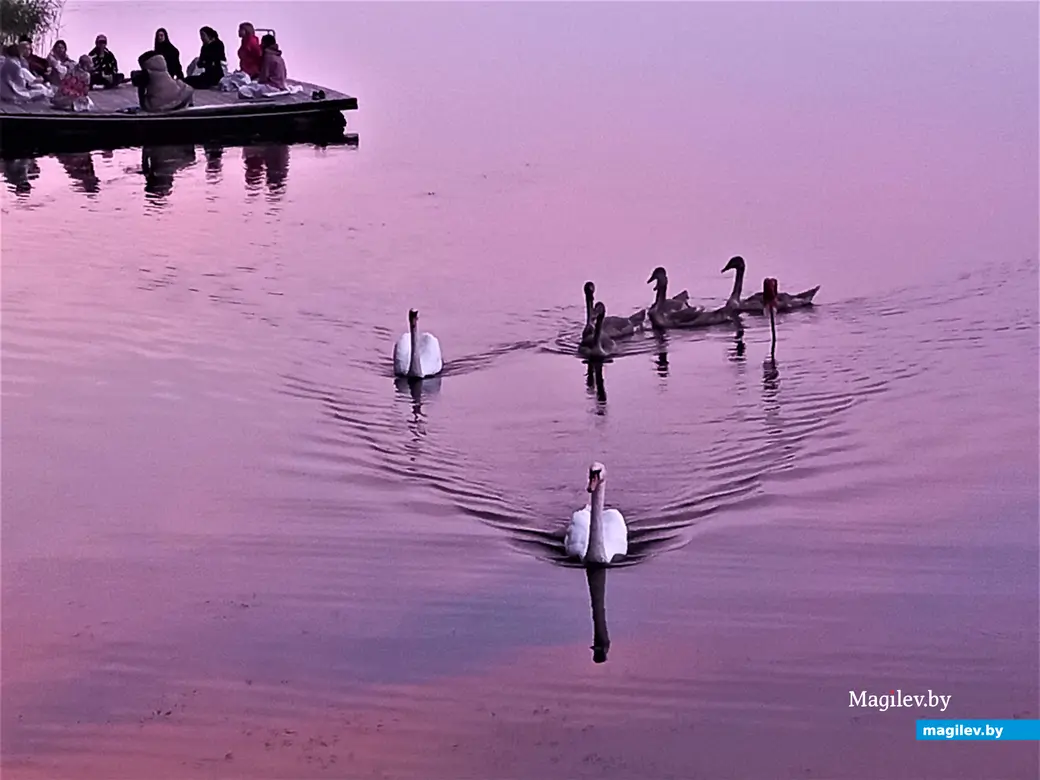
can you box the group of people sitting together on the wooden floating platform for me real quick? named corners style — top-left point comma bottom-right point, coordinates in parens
top-left (0, 22), bottom-right (288, 111)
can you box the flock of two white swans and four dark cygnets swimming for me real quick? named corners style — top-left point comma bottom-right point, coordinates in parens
top-left (393, 256), bottom-right (820, 566)
